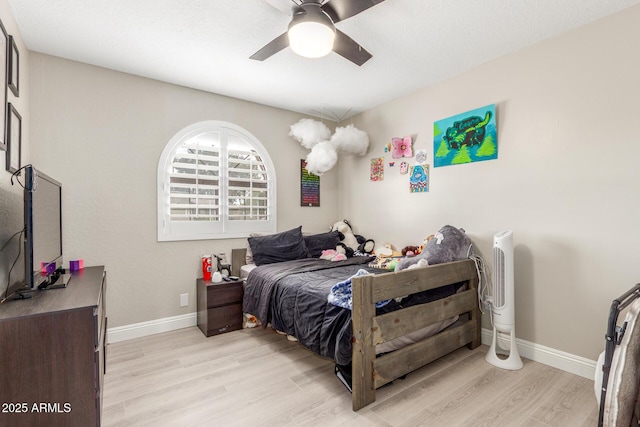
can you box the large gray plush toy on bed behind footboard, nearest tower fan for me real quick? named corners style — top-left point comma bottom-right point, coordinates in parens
top-left (396, 225), bottom-right (473, 271)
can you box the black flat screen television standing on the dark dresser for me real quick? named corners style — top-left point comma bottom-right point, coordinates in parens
top-left (24, 166), bottom-right (66, 289)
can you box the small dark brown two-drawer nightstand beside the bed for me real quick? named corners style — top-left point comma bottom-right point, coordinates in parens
top-left (196, 279), bottom-right (244, 337)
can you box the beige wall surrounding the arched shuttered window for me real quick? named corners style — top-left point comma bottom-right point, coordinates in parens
top-left (30, 53), bottom-right (338, 327)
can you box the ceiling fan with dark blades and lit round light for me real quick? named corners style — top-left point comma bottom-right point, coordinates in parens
top-left (250, 0), bottom-right (384, 66)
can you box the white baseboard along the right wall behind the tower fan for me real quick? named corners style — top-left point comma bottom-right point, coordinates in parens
top-left (482, 328), bottom-right (596, 380)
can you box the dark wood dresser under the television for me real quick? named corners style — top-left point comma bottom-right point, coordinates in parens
top-left (0, 267), bottom-right (107, 427)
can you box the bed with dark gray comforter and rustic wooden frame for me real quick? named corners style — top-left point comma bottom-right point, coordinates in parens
top-left (232, 227), bottom-right (480, 411)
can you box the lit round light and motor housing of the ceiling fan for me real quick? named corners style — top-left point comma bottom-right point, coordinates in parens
top-left (288, 3), bottom-right (336, 58)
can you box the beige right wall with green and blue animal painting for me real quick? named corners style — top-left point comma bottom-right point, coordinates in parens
top-left (341, 7), bottom-right (640, 360)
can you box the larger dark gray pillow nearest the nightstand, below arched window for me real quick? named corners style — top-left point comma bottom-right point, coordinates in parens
top-left (247, 226), bottom-right (309, 265)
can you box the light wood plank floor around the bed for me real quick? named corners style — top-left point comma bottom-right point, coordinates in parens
top-left (102, 327), bottom-right (598, 427)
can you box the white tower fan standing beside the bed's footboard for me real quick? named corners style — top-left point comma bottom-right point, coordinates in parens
top-left (486, 230), bottom-right (522, 371)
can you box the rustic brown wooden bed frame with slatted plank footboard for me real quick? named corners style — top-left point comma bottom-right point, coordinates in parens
top-left (232, 249), bottom-right (481, 411)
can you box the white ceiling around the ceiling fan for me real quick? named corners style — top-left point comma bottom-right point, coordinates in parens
top-left (8, 0), bottom-right (640, 120)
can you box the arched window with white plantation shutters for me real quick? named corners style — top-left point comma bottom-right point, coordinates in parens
top-left (158, 121), bottom-right (276, 241)
